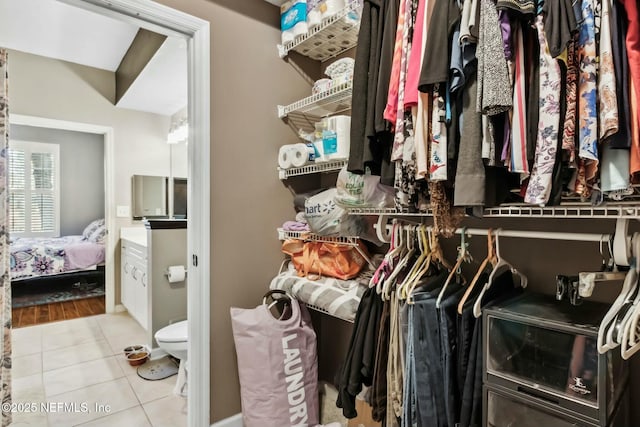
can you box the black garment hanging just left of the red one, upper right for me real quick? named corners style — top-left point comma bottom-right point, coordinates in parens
top-left (606, 1), bottom-right (631, 148)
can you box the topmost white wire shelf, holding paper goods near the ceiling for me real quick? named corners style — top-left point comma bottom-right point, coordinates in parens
top-left (278, 2), bottom-right (360, 61)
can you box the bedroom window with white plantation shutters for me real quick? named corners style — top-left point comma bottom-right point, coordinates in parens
top-left (9, 141), bottom-right (60, 237)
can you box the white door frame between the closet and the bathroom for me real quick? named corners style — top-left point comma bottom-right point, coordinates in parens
top-left (58, 0), bottom-right (211, 427)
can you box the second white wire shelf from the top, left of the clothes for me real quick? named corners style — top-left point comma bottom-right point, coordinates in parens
top-left (278, 80), bottom-right (353, 132)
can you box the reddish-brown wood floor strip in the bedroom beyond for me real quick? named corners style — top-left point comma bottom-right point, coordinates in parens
top-left (11, 296), bottom-right (105, 328)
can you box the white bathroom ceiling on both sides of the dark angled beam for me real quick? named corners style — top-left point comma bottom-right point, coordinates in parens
top-left (0, 0), bottom-right (187, 115)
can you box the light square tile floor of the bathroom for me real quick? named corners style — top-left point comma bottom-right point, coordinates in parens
top-left (11, 313), bottom-right (187, 427)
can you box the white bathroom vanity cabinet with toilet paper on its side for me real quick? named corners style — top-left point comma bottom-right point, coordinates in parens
top-left (120, 219), bottom-right (187, 348)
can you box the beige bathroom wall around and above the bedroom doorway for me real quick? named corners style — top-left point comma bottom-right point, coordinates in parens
top-left (9, 51), bottom-right (186, 303)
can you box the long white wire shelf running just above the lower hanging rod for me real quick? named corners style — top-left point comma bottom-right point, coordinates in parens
top-left (347, 202), bottom-right (640, 220)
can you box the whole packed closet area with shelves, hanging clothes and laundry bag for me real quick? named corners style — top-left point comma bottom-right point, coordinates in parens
top-left (231, 0), bottom-right (640, 427)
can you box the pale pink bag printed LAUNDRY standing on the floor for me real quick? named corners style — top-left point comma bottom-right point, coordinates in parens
top-left (231, 290), bottom-right (319, 427)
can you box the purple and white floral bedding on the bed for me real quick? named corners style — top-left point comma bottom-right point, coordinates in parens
top-left (11, 236), bottom-right (105, 280)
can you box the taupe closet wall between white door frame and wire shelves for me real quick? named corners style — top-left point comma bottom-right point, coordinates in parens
top-left (152, 0), bottom-right (310, 422)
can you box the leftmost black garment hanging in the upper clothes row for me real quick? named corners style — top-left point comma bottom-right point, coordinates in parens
top-left (348, 0), bottom-right (383, 174)
